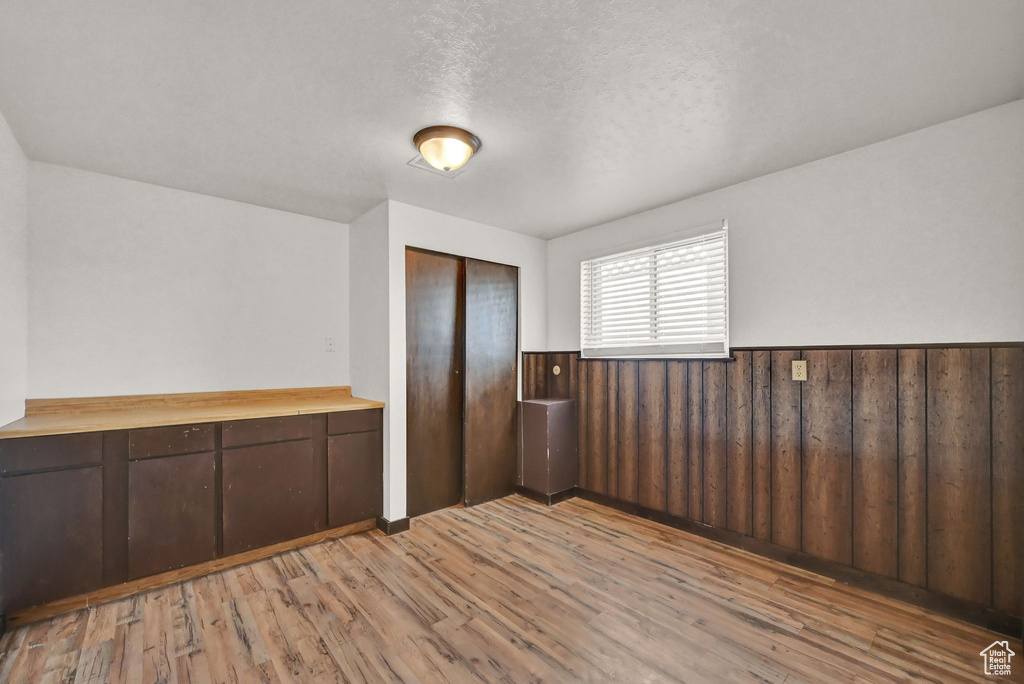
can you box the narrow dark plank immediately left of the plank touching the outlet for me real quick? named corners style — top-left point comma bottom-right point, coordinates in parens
top-left (751, 351), bottom-right (771, 542)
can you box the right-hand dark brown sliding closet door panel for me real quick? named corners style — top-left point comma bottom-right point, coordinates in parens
top-left (465, 259), bottom-right (519, 506)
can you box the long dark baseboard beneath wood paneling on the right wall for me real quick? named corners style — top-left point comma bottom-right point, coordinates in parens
top-left (573, 487), bottom-right (1024, 638)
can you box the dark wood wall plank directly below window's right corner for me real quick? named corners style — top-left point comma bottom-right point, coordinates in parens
top-left (703, 361), bottom-right (729, 527)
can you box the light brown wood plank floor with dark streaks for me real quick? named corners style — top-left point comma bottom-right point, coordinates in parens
top-left (0, 497), bottom-right (1024, 683)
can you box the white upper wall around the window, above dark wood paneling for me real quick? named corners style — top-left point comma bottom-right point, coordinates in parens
top-left (547, 100), bottom-right (1024, 349)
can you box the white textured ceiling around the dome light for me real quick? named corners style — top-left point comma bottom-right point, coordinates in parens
top-left (0, 0), bottom-right (1024, 237)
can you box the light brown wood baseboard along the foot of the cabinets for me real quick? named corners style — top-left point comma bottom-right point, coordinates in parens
top-left (5, 518), bottom-right (374, 627)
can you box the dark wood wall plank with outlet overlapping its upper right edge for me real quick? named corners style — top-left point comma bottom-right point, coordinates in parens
top-left (771, 351), bottom-right (804, 551)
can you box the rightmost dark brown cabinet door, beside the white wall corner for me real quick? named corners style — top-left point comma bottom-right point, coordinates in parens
top-left (327, 432), bottom-right (384, 527)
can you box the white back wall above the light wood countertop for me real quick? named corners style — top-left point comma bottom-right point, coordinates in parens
top-left (29, 163), bottom-right (349, 397)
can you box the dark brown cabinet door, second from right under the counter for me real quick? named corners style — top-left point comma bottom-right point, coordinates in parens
top-left (223, 439), bottom-right (315, 555)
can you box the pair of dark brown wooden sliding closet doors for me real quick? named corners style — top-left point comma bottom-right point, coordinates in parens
top-left (406, 249), bottom-right (519, 516)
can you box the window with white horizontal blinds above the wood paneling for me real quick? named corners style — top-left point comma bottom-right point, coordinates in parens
top-left (580, 221), bottom-right (729, 357)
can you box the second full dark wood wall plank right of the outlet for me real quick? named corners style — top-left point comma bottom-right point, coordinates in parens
top-left (853, 349), bottom-right (899, 578)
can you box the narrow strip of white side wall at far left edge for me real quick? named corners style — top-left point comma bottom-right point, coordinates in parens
top-left (0, 109), bottom-right (29, 425)
